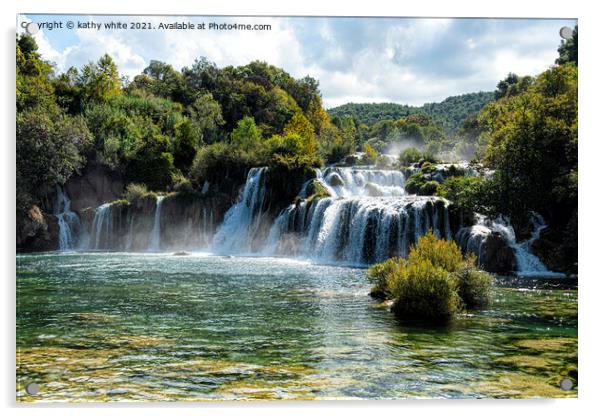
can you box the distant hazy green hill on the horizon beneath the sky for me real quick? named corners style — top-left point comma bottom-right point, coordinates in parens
top-left (328, 91), bottom-right (494, 133)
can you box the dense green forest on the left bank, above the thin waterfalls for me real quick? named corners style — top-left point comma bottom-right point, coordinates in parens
top-left (17, 35), bottom-right (356, 213)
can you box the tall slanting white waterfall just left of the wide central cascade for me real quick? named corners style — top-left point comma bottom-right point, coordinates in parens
top-left (213, 167), bottom-right (267, 254)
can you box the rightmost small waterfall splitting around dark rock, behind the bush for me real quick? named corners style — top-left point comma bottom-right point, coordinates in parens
top-left (456, 212), bottom-right (564, 277)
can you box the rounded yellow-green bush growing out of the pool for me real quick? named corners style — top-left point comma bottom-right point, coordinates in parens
top-left (368, 232), bottom-right (492, 321)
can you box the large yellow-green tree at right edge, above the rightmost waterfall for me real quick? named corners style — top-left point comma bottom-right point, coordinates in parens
top-left (479, 63), bottom-right (577, 227)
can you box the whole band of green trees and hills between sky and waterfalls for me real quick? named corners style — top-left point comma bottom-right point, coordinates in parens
top-left (16, 30), bottom-right (577, 272)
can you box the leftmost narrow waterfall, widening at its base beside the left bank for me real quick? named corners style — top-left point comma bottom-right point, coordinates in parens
top-left (54, 185), bottom-right (87, 251)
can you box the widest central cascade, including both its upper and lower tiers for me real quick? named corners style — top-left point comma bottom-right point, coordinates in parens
top-left (263, 168), bottom-right (451, 264)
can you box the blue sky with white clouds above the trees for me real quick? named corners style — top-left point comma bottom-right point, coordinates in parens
top-left (17, 15), bottom-right (577, 108)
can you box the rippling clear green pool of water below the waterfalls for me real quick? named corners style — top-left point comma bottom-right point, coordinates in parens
top-left (17, 253), bottom-right (577, 401)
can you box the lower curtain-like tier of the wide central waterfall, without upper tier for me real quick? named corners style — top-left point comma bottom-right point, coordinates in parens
top-left (264, 195), bottom-right (448, 264)
